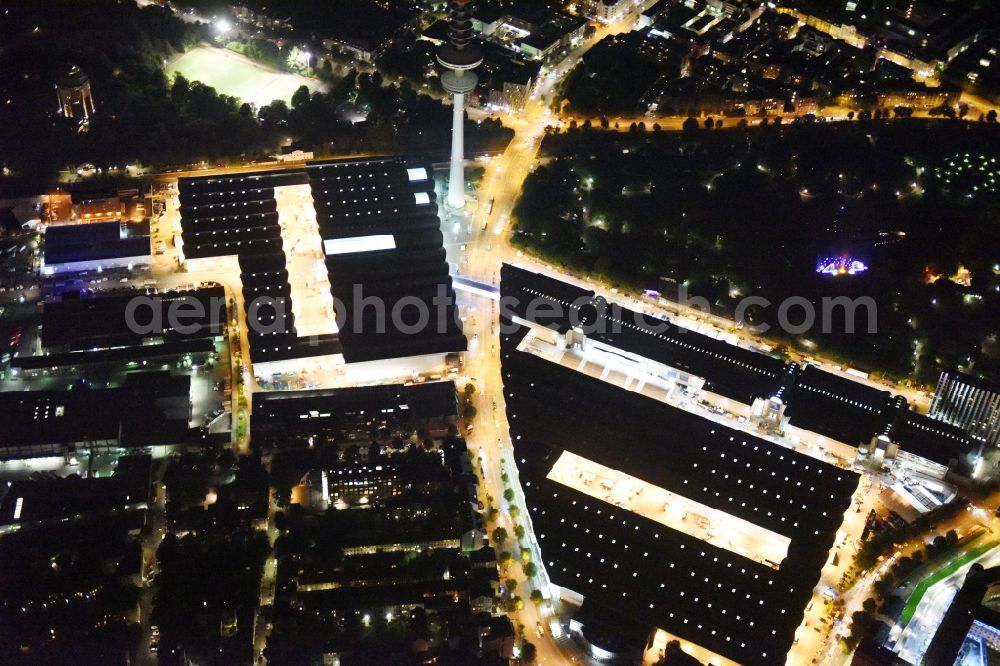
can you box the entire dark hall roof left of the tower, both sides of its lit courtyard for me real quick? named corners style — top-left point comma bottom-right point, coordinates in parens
top-left (179, 157), bottom-right (467, 363)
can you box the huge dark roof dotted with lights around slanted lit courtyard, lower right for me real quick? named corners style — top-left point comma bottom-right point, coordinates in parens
top-left (501, 314), bottom-right (858, 664)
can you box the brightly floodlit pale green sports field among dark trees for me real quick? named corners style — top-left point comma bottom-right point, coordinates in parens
top-left (166, 46), bottom-right (317, 106)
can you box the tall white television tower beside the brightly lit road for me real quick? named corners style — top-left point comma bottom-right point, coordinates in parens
top-left (438, 0), bottom-right (483, 209)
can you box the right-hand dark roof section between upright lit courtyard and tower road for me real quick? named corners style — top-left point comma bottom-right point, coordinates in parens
top-left (306, 157), bottom-right (467, 363)
